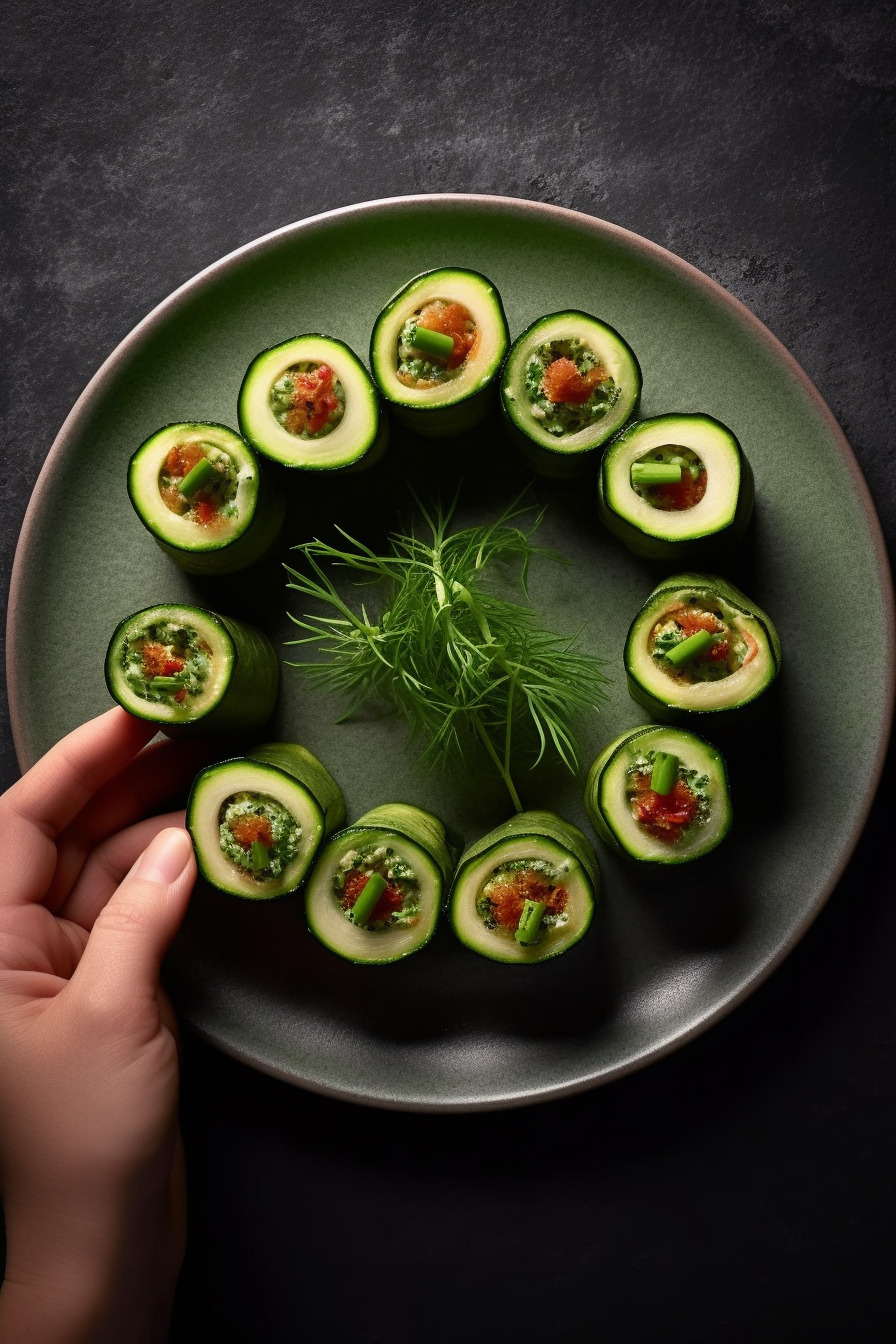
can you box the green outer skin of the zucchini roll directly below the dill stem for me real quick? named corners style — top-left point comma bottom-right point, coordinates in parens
top-left (450, 810), bottom-right (600, 965)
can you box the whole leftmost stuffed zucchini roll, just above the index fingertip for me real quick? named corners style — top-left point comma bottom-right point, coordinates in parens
top-left (106, 603), bottom-right (279, 735)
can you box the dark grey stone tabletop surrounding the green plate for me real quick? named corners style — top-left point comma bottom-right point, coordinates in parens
top-left (0, 0), bottom-right (896, 1344)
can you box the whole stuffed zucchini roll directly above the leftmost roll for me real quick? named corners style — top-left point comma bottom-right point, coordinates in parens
top-left (128, 421), bottom-right (285, 574)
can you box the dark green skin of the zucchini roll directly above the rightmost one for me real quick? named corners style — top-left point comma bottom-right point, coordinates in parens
top-left (598, 414), bottom-right (755, 564)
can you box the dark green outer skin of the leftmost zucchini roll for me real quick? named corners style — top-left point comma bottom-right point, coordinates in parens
top-left (105, 603), bottom-right (279, 738)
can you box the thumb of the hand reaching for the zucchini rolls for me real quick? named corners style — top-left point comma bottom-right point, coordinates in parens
top-left (73, 828), bottom-right (196, 1008)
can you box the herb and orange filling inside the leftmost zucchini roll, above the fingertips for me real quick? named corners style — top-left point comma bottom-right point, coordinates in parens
top-left (121, 621), bottom-right (212, 708)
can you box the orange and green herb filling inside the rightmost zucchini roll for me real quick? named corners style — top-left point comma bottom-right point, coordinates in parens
top-left (649, 595), bottom-right (759, 685)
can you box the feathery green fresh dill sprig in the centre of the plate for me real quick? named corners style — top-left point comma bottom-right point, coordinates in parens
top-left (285, 501), bottom-right (606, 812)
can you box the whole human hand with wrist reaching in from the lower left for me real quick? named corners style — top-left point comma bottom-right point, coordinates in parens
top-left (0, 708), bottom-right (208, 1344)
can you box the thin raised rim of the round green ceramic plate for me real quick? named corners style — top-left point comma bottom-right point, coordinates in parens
top-left (5, 192), bottom-right (896, 1114)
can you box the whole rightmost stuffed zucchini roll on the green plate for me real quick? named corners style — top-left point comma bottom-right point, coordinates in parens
top-left (623, 574), bottom-right (780, 722)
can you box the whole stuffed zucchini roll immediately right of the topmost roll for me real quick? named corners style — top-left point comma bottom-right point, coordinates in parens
top-left (501, 312), bottom-right (641, 477)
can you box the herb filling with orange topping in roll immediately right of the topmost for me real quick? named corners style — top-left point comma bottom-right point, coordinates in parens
top-left (525, 336), bottom-right (621, 438)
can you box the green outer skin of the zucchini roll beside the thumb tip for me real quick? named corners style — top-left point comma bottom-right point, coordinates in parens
top-left (185, 742), bottom-right (345, 902)
